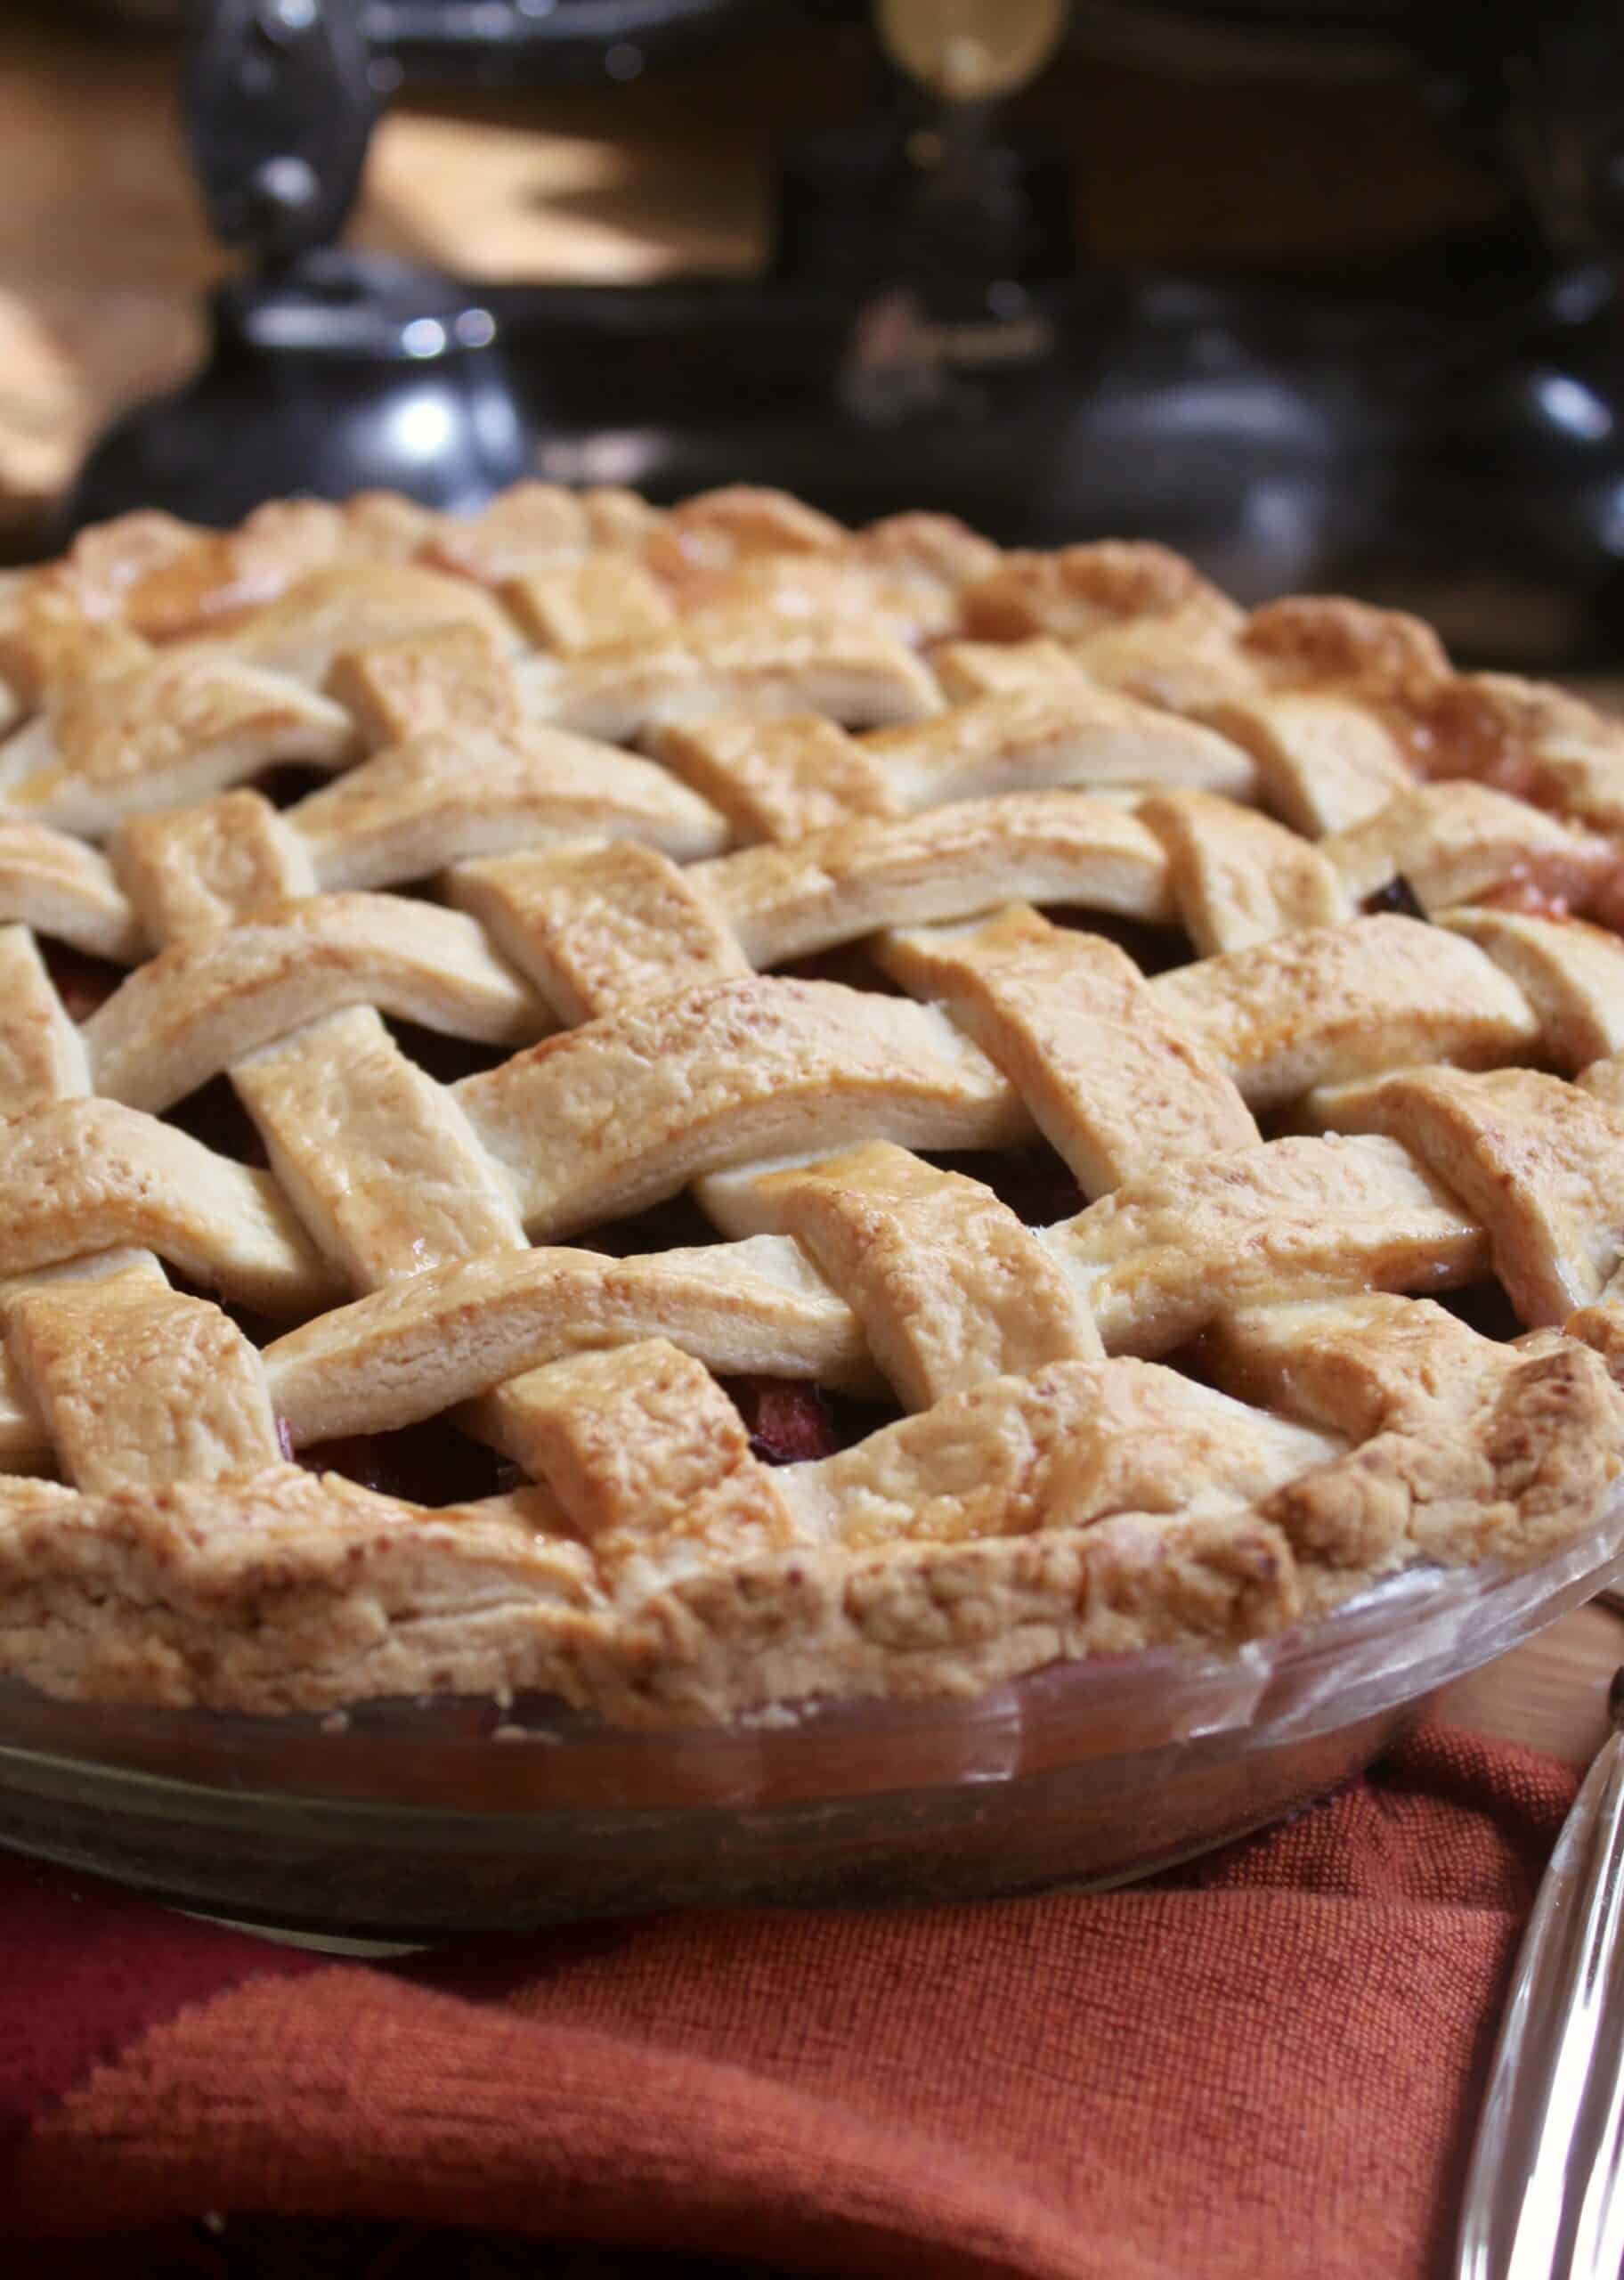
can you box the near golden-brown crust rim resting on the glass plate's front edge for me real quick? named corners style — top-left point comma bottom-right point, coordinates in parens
top-left (0, 1313), bottom-right (1620, 1726)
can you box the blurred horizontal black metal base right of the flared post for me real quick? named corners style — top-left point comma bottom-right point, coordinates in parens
top-left (481, 246), bottom-right (1624, 668)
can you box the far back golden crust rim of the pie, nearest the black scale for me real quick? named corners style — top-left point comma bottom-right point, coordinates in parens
top-left (0, 485), bottom-right (1624, 875)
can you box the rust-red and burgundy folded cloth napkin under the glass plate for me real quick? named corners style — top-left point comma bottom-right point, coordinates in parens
top-left (0, 1728), bottom-right (1574, 2280)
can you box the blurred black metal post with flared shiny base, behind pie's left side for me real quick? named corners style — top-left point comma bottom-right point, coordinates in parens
top-left (61, 0), bottom-right (532, 529)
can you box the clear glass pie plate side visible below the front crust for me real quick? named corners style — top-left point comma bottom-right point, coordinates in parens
top-left (0, 1491), bottom-right (1624, 1941)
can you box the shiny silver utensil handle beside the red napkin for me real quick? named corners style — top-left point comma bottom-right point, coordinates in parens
top-left (1455, 1668), bottom-right (1624, 2280)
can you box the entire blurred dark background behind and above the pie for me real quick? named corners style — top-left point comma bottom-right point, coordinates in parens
top-left (0, 0), bottom-right (1624, 668)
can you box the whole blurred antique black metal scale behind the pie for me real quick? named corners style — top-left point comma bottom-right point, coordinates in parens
top-left (69, 0), bottom-right (1624, 671)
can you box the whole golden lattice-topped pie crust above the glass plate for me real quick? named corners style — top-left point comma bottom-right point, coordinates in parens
top-left (0, 485), bottom-right (1624, 1723)
